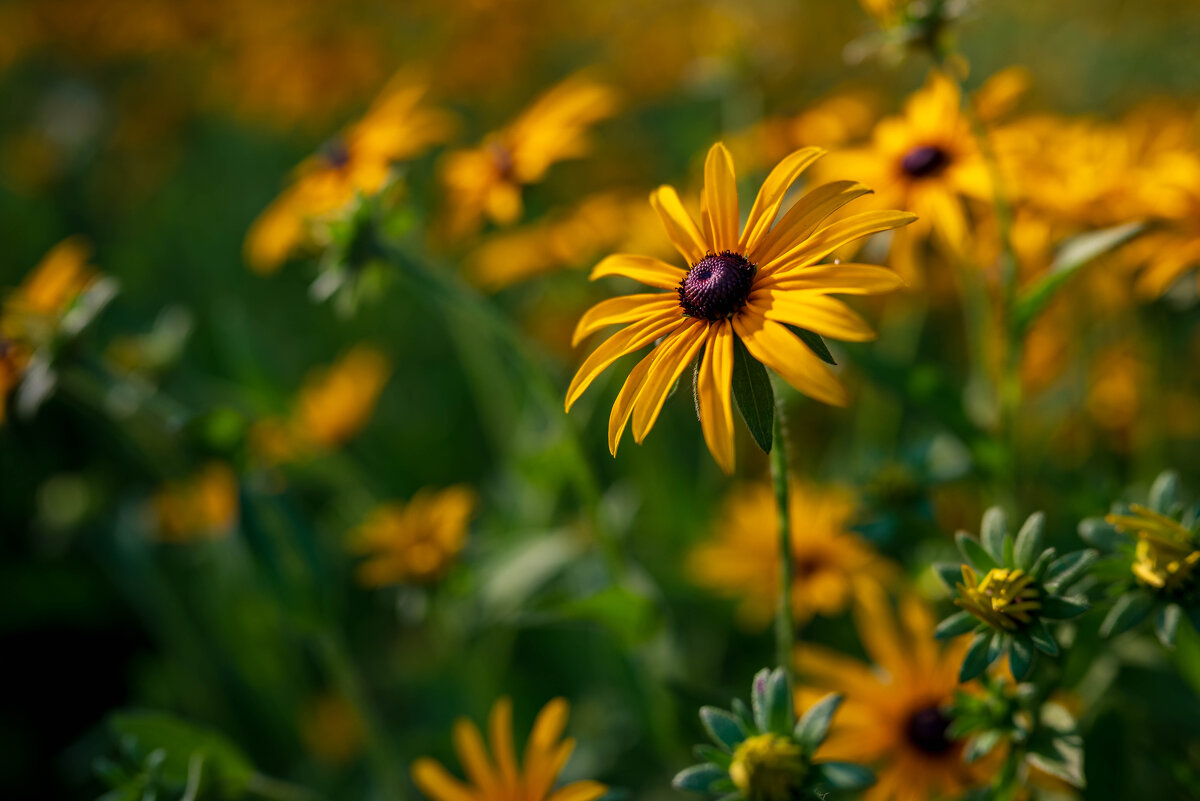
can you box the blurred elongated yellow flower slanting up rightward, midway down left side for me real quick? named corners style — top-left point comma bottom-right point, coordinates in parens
top-left (251, 345), bottom-right (391, 464)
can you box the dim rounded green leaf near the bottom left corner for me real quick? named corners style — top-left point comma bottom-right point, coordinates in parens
top-left (108, 712), bottom-right (254, 793)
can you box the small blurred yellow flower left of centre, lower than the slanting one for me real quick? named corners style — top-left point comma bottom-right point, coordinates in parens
top-left (354, 486), bottom-right (475, 586)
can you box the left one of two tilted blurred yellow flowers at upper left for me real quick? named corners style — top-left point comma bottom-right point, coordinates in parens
top-left (245, 76), bottom-right (454, 272)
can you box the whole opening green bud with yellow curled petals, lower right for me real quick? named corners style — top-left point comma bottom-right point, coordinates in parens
top-left (936, 506), bottom-right (1096, 681)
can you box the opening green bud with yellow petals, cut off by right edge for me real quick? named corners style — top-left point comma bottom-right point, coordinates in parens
top-left (1079, 471), bottom-right (1200, 648)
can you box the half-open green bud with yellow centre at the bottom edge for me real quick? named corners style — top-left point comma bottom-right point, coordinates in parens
top-left (673, 668), bottom-right (872, 801)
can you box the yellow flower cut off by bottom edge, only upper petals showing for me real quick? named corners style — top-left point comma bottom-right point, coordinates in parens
top-left (413, 698), bottom-right (608, 801)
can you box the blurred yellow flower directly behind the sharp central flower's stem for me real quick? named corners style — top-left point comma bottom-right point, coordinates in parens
top-left (688, 482), bottom-right (894, 626)
